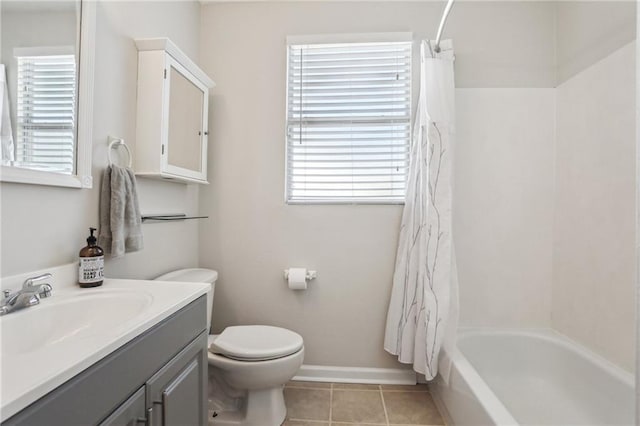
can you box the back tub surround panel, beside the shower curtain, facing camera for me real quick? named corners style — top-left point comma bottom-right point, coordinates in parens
top-left (453, 89), bottom-right (555, 327)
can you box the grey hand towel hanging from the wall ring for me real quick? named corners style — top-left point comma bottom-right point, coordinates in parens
top-left (98, 165), bottom-right (143, 258)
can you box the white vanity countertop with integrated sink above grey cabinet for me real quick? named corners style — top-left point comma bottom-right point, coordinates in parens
top-left (0, 279), bottom-right (210, 421)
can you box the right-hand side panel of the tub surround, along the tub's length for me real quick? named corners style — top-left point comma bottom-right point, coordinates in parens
top-left (552, 43), bottom-right (636, 370)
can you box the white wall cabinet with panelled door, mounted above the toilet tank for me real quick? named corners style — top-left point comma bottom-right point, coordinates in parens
top-left (134, 38), bottom-right (215, 183)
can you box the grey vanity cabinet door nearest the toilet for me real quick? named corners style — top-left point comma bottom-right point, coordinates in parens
top-left (147, 333), bottom-right (207, 426)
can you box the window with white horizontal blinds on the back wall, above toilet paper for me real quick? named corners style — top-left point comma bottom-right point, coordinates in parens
top-left (286, 42), bottom-right (411, 203)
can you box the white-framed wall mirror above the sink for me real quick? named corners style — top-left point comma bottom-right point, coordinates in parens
top-left (0, 0), bottom-right (95, 188)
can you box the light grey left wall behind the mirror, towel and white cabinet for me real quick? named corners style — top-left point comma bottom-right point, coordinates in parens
top-left (0, 1), bottom-right (200, 278)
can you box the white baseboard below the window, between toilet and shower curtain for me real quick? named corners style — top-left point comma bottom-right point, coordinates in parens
top-left (292, 365), bottom-right (416, 385)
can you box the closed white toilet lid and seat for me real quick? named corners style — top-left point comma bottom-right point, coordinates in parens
top-left (209, 325), bottom-right (303, 361)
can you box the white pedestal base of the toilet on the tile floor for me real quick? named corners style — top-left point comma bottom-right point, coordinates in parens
top-left (209, 386), bottom-right (287, 426)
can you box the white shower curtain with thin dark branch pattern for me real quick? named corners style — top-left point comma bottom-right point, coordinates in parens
top-left (384, 40), bottom-right (457, 380)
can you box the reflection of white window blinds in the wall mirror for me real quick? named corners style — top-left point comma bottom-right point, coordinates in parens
top-left (16, 55), bottom-right (76, 174)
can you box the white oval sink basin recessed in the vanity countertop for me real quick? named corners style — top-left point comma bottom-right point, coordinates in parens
top-left (0, 290), bottom-right (153, 356)
